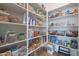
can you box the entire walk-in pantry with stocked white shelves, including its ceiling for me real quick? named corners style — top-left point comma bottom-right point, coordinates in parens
top-left (0, 3), bottom-right (79, 56)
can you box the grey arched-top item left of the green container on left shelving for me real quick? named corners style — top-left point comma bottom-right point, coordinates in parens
top-left (5, 31), bottom-right (18, 43)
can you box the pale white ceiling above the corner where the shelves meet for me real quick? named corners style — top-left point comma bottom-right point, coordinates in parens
top-left (44, 3), bottom-right (69, 11)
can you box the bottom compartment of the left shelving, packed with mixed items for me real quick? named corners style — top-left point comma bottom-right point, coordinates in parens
top-left (0, 42), bottom-right (27, 56)
